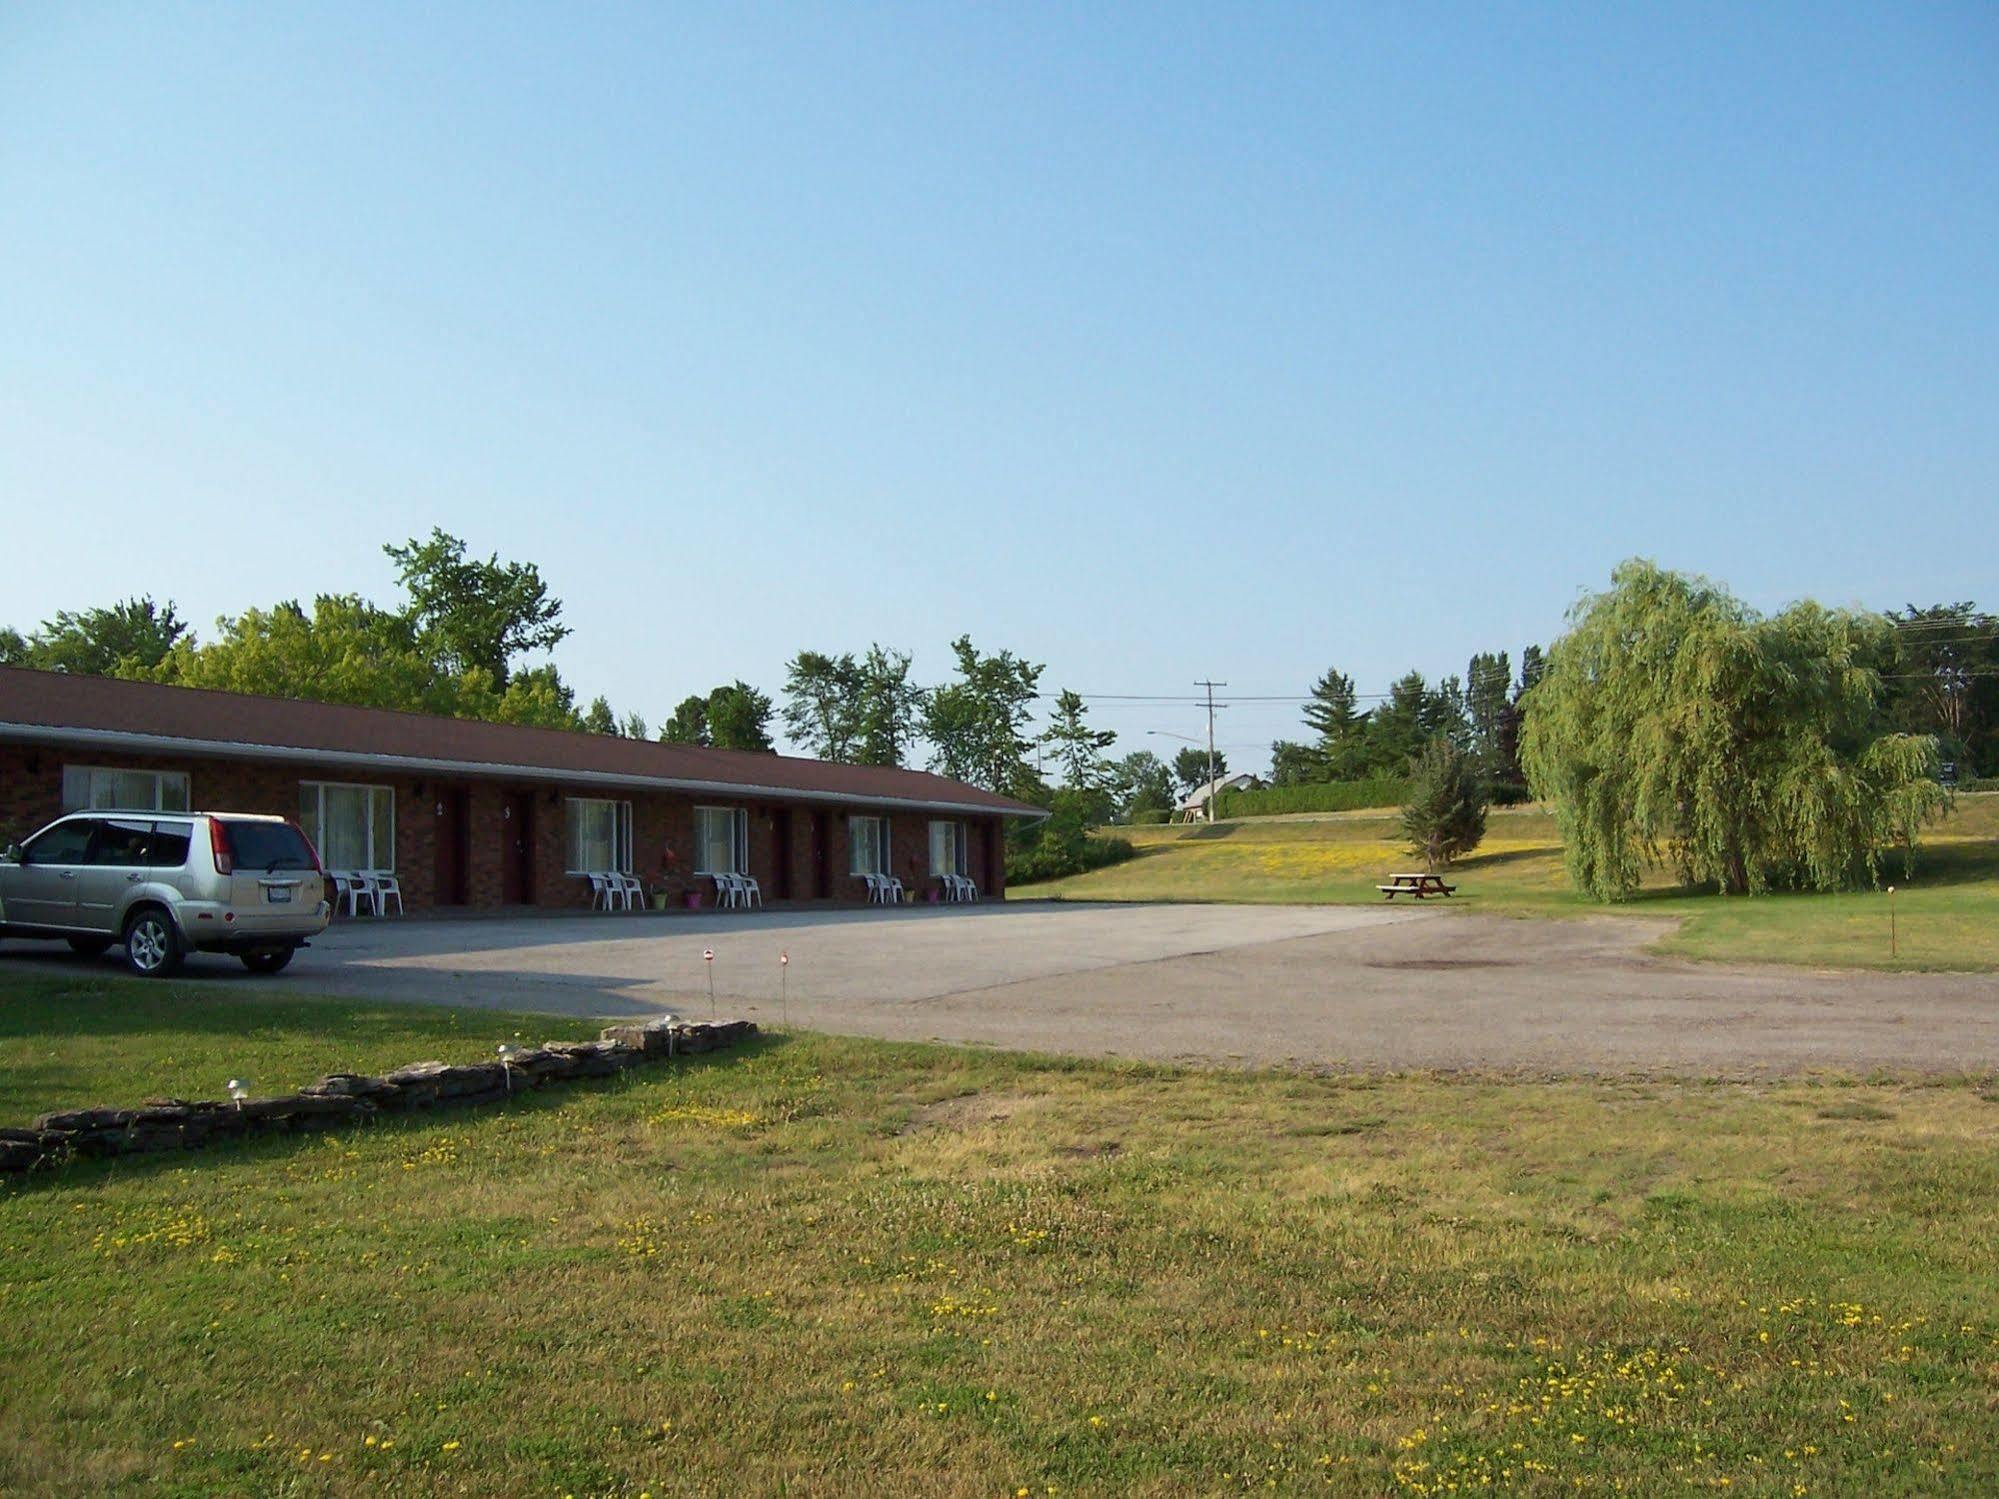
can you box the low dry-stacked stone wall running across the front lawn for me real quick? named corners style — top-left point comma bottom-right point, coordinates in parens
top-left (0, 1019), bottom-right (756, 1171)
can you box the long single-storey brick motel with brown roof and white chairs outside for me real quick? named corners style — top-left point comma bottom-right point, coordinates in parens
top-left (0, 668), bottom-right (1043, 911)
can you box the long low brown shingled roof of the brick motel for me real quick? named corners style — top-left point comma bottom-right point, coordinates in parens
top-left (0, 668), bottom-right (1041, 815)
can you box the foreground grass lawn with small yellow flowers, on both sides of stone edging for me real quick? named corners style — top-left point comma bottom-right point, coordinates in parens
top-left (11, 973), bottom-right (1999, 1495)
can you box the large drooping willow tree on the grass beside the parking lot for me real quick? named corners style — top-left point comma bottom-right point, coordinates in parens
top-left (1521, 562), bottom-right (1945, 899)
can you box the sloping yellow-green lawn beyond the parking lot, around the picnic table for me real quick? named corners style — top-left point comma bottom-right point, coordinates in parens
top-left (1011, 791), bottom-right (1999, 969)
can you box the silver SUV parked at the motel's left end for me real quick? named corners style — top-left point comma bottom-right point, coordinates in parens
top-left (0, 811), bottom-right (332, 977)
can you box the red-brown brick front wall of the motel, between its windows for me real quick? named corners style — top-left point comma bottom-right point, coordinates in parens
top-left (0, 746), bottom-right (1005, 911)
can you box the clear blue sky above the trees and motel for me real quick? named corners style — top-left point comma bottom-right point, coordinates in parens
top-left (0, 2), bottom-right (1999, 761)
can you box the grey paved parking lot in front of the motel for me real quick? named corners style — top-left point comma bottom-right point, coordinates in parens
top-left (15, 901), bottom-right (1999, 1077)
